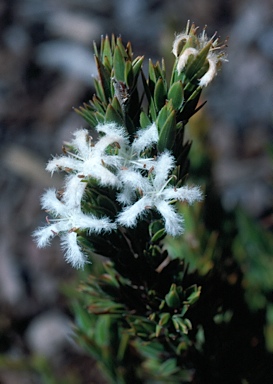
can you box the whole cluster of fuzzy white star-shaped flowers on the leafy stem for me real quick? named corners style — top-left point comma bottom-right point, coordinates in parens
top-left (34, 123), bottom-right (202, 267)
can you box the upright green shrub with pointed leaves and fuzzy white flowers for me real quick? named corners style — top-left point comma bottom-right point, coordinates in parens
top-left (34, 23), bottom-right (269, 384)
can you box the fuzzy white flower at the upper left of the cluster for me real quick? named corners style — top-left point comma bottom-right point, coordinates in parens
top-left (46, 123), bottom-right (127, 186)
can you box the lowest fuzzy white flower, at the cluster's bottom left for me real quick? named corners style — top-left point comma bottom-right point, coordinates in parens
top-left (33, 189), bottom-right (116, 268)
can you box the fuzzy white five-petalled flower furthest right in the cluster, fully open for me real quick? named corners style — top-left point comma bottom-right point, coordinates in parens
top-left (117, 152), bottom-right (202, 236)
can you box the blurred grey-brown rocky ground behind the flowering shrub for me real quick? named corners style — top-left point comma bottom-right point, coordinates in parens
top-left (0, 0), bottom-right (273, 384)
